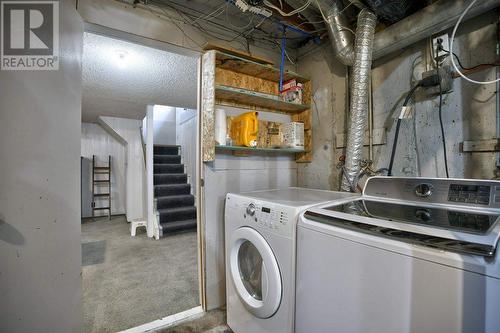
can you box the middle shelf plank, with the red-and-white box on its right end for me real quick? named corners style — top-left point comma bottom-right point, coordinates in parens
top-left (215, 85), bottom-right (310, 113)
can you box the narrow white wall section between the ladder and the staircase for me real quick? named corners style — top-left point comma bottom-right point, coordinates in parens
top-left (98, 117), bottom-right (146, 222)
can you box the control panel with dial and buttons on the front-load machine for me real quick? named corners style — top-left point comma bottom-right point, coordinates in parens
top-left (243, 201), bottom-right (294, 236)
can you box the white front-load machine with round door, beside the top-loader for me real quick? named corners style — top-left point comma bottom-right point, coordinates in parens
top-left (225, 188), bottom-right (355, 333)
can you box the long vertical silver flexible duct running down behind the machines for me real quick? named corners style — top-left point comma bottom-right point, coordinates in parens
top-left (341, 9), bottom-right (377, 191)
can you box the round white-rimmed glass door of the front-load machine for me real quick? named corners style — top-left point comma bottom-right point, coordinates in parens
top-left (229, 227), bottom-right (283, 318)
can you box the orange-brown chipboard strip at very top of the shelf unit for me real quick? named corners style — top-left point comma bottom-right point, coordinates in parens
top-left (215, 51), bottom-right (309, 83)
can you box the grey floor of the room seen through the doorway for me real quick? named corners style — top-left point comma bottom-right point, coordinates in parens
top-left (82, 216), bottom-right (199, 333)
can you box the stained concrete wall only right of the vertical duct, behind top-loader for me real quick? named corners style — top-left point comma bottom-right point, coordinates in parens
top-left (373, 11), bottom-right (498, 179)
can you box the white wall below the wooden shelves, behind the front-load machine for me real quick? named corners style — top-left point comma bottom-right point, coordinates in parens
top-left (203, 107), bottom-right (297, 309)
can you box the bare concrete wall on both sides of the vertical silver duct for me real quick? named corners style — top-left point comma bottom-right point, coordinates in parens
top-left (297, 12), bottom-right (497, 190)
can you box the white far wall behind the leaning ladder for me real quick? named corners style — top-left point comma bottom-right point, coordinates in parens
top-left (81, 123), bottom-right (126, 217)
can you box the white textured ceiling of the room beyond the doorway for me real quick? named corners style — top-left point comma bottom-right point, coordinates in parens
top-left (82, 33), bottom-right (197, 122)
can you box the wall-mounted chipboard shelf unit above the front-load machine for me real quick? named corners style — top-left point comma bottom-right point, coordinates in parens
top-left (202, 50), bottom-right (312, 163)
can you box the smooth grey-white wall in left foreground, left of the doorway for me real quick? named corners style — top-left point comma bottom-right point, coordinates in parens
top-left (0, 1), bottom-right (83, 333)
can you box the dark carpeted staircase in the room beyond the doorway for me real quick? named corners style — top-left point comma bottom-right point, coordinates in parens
top-left (154, 146), bottom-right (196, 236)
